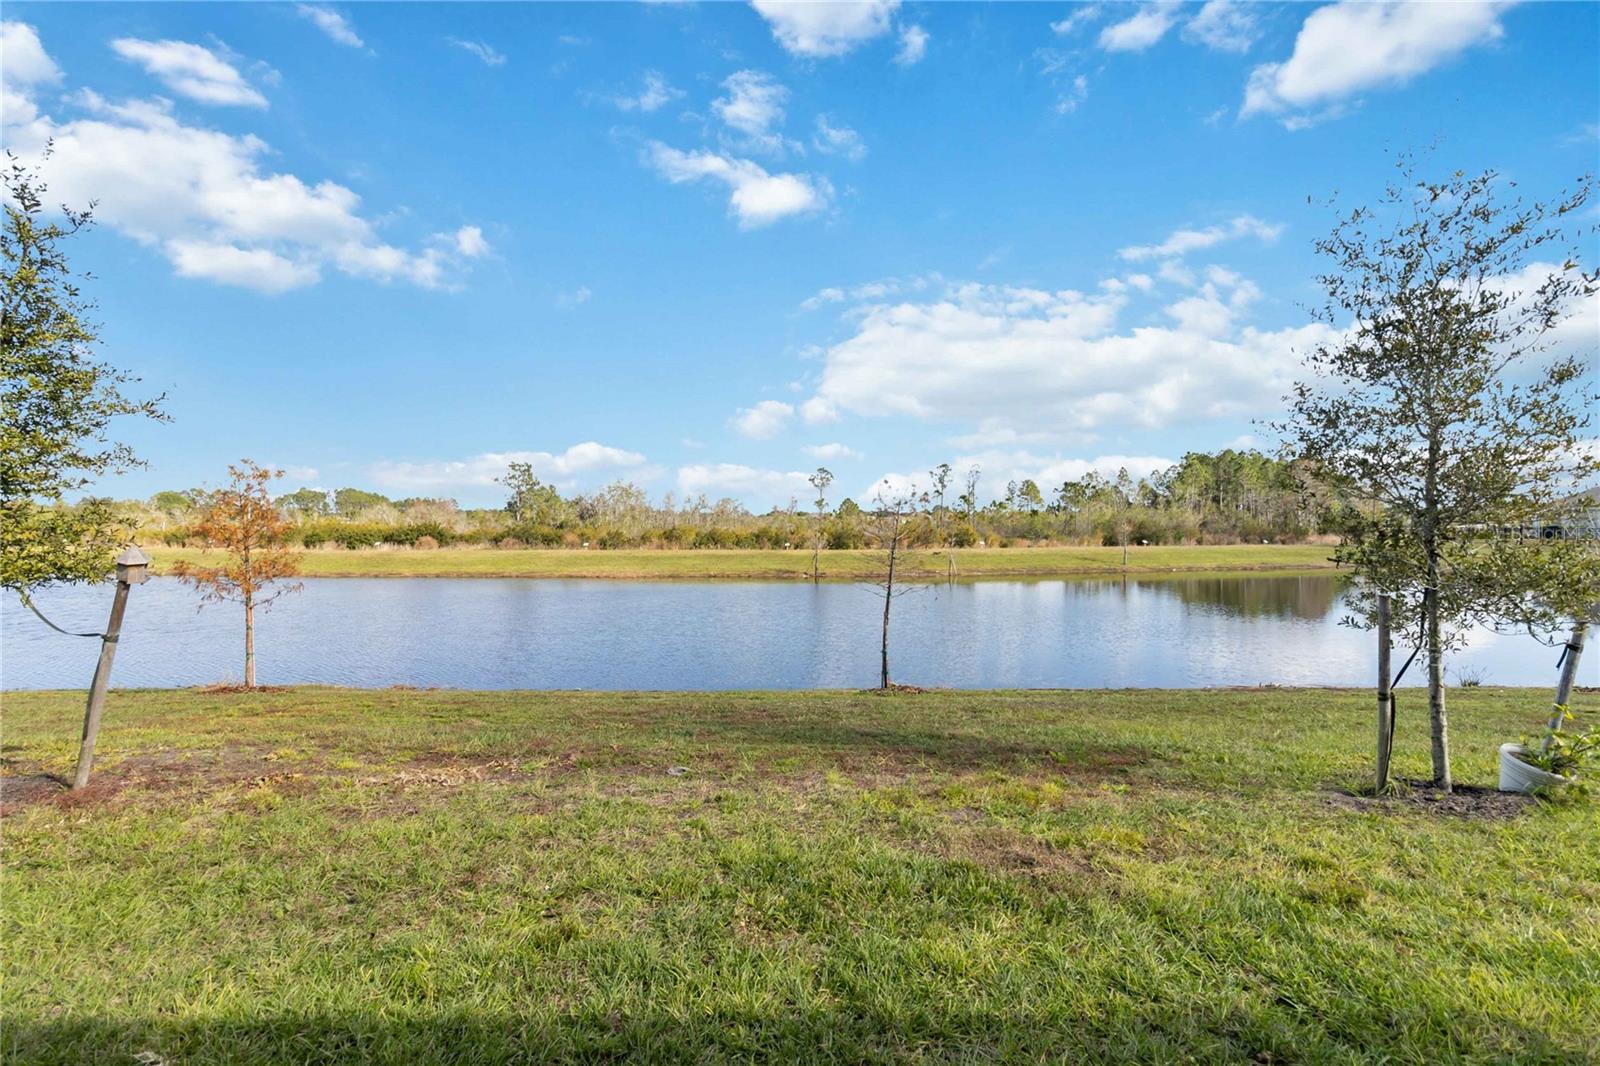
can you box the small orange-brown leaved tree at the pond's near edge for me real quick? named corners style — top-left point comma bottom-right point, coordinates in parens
top-left (173, 459), bottom-right (299, 688)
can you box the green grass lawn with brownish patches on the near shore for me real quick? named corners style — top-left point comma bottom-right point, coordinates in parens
top-left (0, 688), bottom-right (1600, 1064)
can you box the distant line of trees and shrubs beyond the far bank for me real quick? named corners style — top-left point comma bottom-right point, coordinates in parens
top-left (118, 450), bottom-right (1338, 549)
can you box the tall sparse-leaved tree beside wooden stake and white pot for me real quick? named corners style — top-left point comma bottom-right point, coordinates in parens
top-left (1280, 162), bottom-right (1600, 791)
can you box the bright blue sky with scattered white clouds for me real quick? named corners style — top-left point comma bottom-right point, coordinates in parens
top-left (0, 2), bottom-right (1600, 509)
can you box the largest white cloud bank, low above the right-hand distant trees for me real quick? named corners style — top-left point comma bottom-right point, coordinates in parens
top-left (808, 275), bottom-right (1331, 439)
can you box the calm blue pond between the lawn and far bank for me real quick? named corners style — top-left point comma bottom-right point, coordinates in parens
top-left (0, 575), bottom-right (1574, 690)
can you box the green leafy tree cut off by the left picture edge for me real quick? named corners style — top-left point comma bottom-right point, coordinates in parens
top-left (0, 158), bottom-right (166, 599)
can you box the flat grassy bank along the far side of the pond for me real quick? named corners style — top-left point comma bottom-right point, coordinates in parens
top-left (149, 544), bottom-right (1333, 581)
